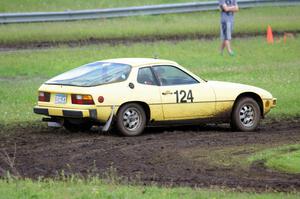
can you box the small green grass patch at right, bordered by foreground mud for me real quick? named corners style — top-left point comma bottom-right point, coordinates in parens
top-left (249, 144), bottom-right (300, 174)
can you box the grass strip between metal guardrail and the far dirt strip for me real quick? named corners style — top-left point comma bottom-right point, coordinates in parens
top-left (0, 6), bottom-right (300, 44)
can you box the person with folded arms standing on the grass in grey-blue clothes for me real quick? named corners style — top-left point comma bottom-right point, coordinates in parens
top-left (219, 0), bottom-right (239, 56)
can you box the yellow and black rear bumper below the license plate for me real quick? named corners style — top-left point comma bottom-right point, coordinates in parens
top-left (33, 106), bottom-right (97, 119)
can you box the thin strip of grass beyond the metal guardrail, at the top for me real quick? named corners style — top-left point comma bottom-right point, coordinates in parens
top-left (0, 0), bottom-right (212, 12)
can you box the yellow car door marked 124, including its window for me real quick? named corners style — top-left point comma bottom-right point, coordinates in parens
top-left (152, 65), bottom-right (215, 120)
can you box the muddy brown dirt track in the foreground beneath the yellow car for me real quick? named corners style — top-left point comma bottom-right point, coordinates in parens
top-left (0, 118), bottom-right (300, 191)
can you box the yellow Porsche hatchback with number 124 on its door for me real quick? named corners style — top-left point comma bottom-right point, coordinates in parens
top-left (34, 58), bottom-right (276, 136)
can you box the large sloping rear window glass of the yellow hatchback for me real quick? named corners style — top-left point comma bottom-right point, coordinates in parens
top-left (46, 62), bottom-right (131, 86)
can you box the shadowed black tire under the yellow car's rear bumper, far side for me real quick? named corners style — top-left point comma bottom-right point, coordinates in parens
top-left (64, 119), bottom-right (93, 133)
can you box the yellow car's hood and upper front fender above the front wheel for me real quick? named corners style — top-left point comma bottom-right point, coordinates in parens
top-left (207, 81), bottom-right (272, 100)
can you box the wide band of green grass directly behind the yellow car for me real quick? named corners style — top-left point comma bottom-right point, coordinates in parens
top-left (0, 37), bottom-right (300, 125)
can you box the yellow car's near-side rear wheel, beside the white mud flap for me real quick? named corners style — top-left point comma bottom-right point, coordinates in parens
top-left (116, 103), bottom-right (146, 136)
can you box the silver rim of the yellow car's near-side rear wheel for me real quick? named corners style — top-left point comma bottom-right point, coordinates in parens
top-left (123, 108), bottom-right (141, 131)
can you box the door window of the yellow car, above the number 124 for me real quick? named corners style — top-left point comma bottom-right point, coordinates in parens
top-left (153, 66), bottom-right (199, 86)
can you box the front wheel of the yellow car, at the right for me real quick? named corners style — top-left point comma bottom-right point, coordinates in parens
top-left (230, 97), bottom-right (261, 132)
